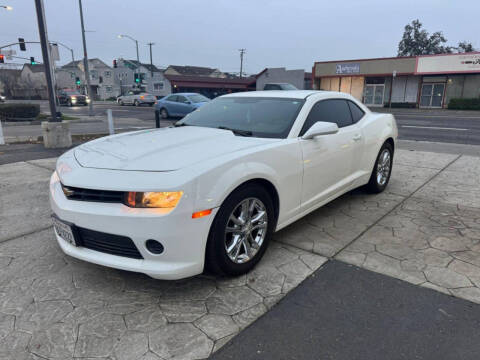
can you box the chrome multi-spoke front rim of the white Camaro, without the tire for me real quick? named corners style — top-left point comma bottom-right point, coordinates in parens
top-left (225, 198), bottom-right (268, 264)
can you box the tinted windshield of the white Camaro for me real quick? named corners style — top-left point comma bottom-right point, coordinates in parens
top-left (178, 97), bottom-right (304, 138)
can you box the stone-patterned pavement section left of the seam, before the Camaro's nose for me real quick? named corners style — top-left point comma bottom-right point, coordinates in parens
top-left (0, 159), bottom-right (326, 360)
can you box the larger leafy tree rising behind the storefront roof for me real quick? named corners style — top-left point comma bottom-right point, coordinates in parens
top-left (398, 19), bottom-right (452, 56)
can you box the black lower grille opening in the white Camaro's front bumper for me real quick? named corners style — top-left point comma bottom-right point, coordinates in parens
top-left (76, 226), bottom-right (143, 259)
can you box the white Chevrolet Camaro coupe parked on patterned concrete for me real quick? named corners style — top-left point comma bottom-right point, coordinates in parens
top-left (50, 90), bottom-right (397, 279)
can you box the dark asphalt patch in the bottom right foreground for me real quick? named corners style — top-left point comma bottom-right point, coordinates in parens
top-left (211, 261), bottom-right (480, 360)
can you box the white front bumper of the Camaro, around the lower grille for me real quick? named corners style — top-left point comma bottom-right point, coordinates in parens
top-left (50, 173), bottom-right (217, 280)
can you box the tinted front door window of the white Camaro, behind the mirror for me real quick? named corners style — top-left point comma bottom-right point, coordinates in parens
top-left (300, 99), bottom-right (352, 136)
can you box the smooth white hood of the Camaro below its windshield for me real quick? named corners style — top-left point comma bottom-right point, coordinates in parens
top-left (74, 126), bottom-right (278, 171)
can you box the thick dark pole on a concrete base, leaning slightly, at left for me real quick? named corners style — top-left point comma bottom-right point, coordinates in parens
top-left (35, 0), bottom-right (57, 122)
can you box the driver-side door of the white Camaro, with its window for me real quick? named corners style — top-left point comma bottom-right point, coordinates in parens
top-left (300, 99), bottom-right (362, 210)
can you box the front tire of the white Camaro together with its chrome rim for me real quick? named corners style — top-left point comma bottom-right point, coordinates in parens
top-left (205, 184), bottom-right (276, 276)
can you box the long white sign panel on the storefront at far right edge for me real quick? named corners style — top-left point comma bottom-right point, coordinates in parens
top-left (415, 53), bottom-right (480, 75)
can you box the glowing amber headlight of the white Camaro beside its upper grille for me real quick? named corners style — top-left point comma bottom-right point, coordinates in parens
top-left (125, 191), bottom-right (183, 209)
